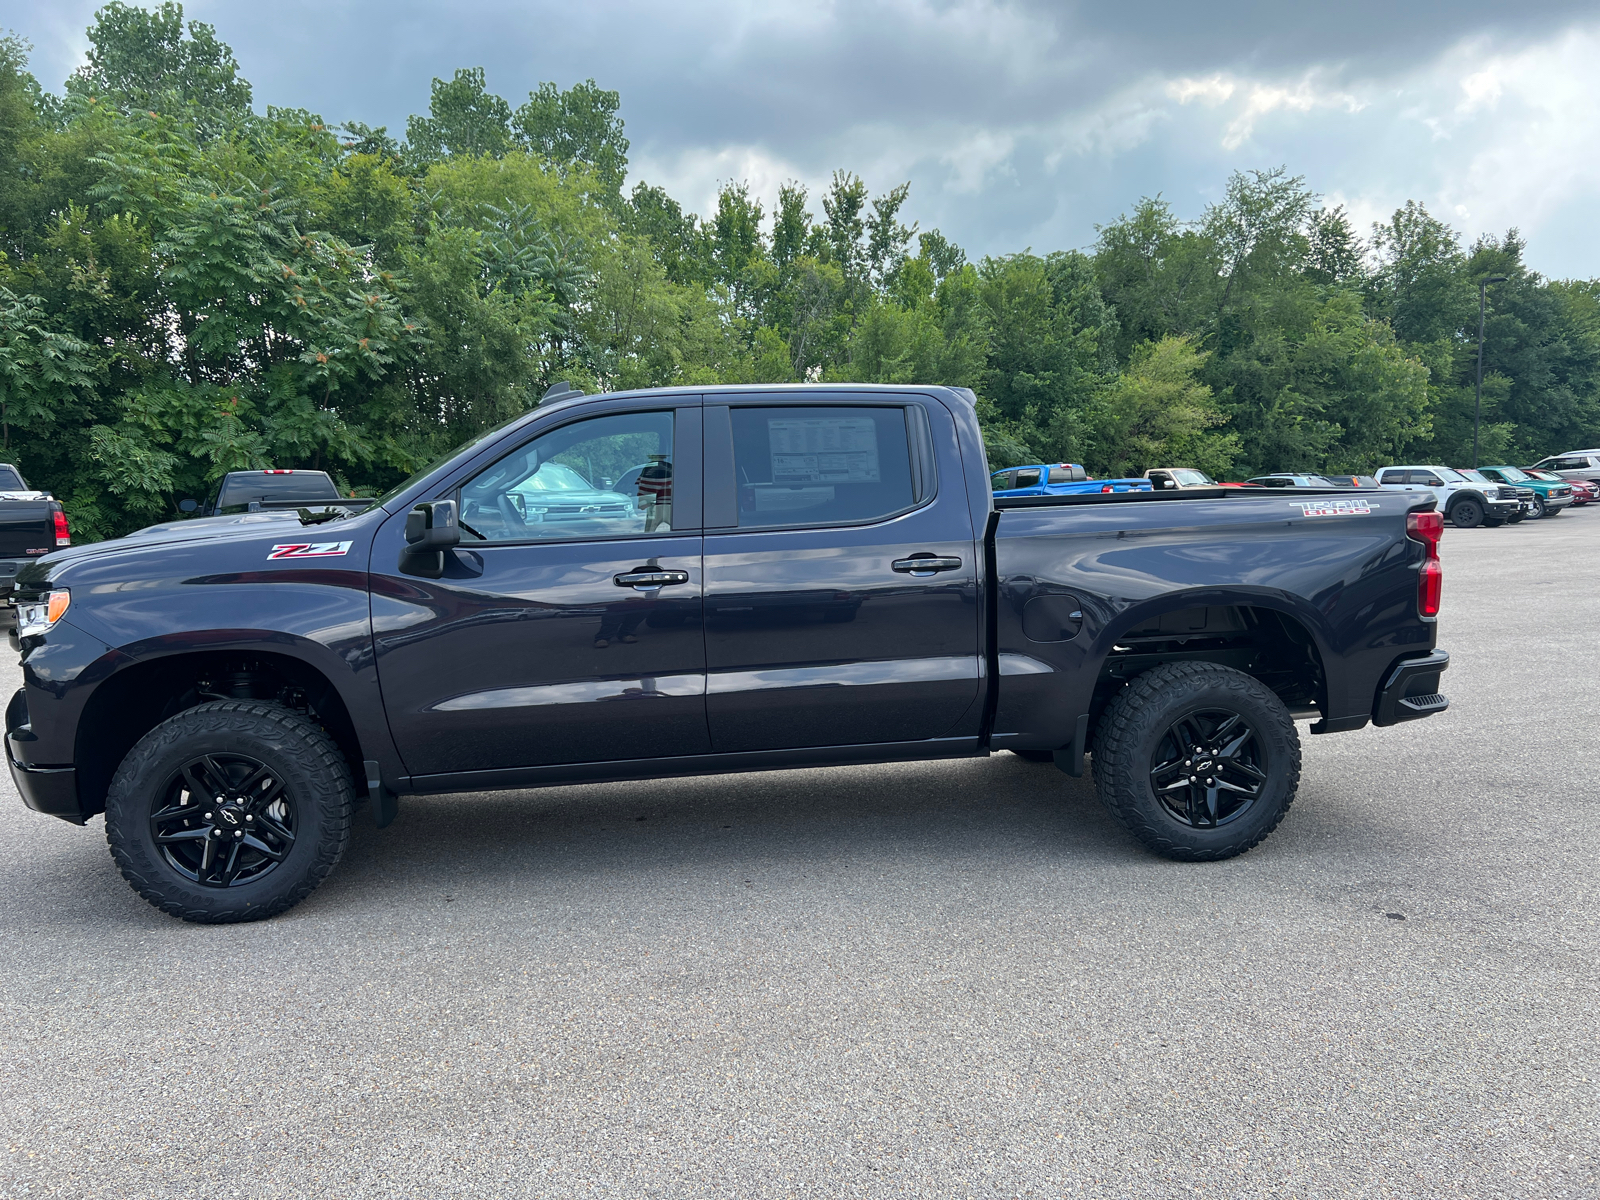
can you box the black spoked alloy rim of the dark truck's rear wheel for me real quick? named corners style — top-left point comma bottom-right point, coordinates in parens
top-left (1150, 709), bottom-right (1267, 829)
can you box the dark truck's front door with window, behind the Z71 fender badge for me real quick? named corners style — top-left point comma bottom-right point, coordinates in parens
top-left (371, 397), bottom-right (710, 784)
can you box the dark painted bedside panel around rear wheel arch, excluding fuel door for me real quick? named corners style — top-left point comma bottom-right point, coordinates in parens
top-left (994, 493), bottom-right (1435, 746)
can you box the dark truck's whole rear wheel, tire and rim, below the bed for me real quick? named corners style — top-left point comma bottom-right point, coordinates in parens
top-left (1093, 662), bottom-right (1301, 862)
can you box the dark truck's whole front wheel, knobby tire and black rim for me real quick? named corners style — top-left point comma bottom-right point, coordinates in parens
top-left (106, 701), bottom-right (352, 923)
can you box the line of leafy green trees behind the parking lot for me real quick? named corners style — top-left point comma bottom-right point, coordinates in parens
top-left (0, 3), bottom-right (1600, 538)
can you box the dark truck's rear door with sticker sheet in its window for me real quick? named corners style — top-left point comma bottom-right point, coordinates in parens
top-left (706, 394), bottom-right (981, 752)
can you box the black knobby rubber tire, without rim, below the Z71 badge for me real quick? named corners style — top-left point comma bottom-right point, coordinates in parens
top-left (106, 701), bottom-right (352, 925)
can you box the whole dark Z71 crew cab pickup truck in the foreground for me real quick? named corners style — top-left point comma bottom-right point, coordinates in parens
top-left (6, 386), bottom-right (1448, 922)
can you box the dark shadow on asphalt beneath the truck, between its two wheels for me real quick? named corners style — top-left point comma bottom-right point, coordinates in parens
top-left (322, 754), bottom-right (1158, 902)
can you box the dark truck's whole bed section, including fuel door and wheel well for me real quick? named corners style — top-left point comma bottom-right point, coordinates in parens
top-left (987, 488), bottom-right (1437, 749)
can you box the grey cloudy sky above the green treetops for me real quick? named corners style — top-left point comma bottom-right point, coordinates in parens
top-left (12, 0), bottom-right (1600, 277)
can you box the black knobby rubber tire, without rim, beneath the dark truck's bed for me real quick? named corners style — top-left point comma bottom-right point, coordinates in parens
top-left (1091, 662), bottom-right (1301, 862)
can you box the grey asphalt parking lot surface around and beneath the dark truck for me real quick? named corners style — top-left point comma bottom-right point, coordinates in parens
top-left (0, 509), bottom-right (1600, 1200)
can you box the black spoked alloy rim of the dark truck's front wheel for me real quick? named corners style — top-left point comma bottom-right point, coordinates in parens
top-left (150, 754), bottom-right (298, 888)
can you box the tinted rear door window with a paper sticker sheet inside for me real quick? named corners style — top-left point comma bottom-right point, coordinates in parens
top-left (730, 405), bottom-right (921, 530)
